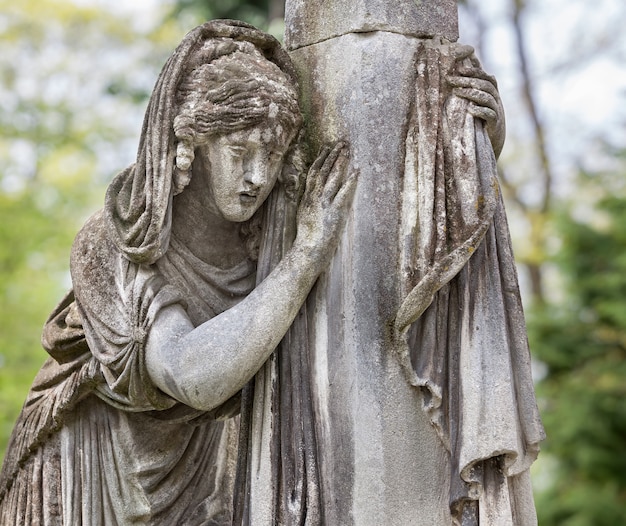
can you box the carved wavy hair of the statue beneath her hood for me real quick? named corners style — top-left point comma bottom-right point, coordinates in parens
top-left (168, 38), bottom-right (302, 193)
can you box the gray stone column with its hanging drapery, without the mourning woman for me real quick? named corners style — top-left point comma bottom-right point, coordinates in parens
top-left (250, 0), bottom-right (543, 526)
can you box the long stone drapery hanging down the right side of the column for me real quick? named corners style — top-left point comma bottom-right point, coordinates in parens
top-left (395, 41), bottom-right (544, 526)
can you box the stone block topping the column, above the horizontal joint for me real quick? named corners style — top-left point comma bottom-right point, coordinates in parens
top-left (285, 0), bottom-right (459, 50)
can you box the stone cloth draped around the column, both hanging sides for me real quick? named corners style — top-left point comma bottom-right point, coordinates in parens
top-left (235, 40), bottom-right (544, 526)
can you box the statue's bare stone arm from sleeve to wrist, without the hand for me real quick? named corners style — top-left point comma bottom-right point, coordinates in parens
top-left (146, 246), bottom-right (325, 410)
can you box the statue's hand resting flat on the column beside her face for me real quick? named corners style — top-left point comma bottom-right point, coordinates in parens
top-left (294, 141), bottom-right (357, 264)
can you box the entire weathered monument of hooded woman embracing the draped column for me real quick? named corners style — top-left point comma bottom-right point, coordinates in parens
top-left (0, 9), bottom-right (542, 526)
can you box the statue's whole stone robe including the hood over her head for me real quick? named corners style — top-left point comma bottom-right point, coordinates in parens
top-left (0, 20), bottom-right (297, 526)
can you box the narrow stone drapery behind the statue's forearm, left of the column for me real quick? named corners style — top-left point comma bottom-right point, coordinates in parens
top-left (233, 183), bottom-right (323, 526)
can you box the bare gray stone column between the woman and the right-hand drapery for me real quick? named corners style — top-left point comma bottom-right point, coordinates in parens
top-left (286, 0), bottom-right (457, 526)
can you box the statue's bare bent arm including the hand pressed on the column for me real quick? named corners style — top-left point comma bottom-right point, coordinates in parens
top-left (145, 145), bottom-right (356, 410)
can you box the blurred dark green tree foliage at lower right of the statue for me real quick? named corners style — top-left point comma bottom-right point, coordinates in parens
top-left (528, 152), bottom-right (626, 526)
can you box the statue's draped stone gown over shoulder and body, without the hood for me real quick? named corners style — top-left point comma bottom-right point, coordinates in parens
top-left (0, 214), bottom-right (255, 526)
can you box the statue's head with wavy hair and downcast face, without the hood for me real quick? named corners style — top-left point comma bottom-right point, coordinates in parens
top-left (174, 38), bottom-right (302, 211)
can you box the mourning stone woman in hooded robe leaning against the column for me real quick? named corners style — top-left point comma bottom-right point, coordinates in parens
top-left (0, 21), bottom-right (356, 526)
